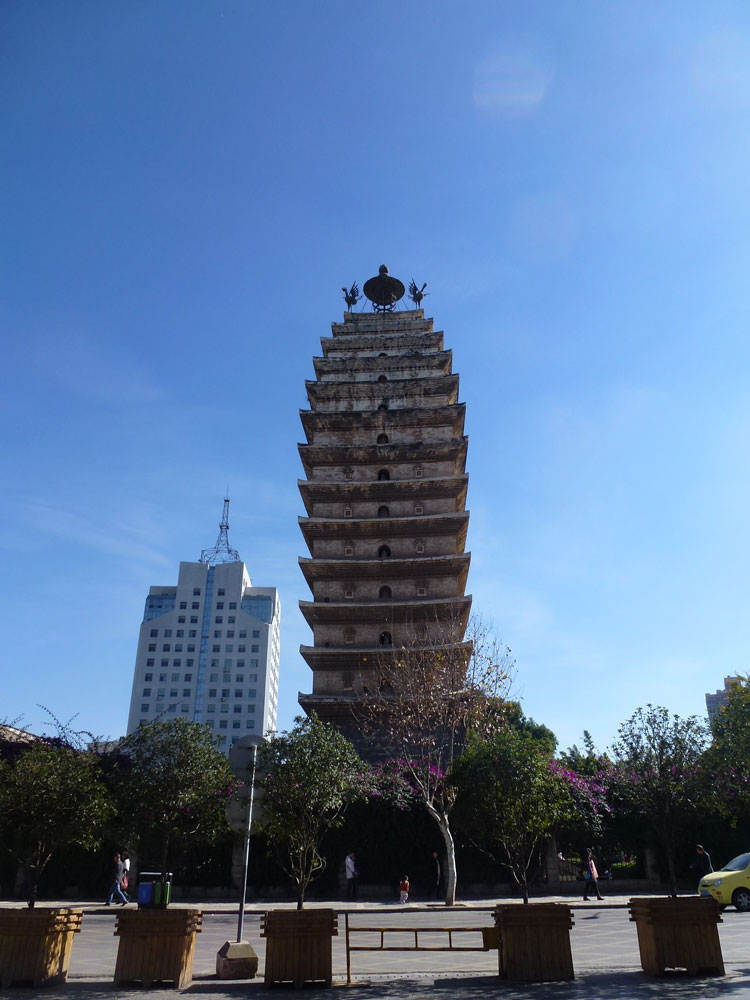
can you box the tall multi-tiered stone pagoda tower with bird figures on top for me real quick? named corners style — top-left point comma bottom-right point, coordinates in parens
top-left (299, 267), bottom-right (471, 736)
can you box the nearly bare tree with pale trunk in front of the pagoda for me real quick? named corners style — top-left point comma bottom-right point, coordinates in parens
top-left (356, 622), bottom-right (512, 906)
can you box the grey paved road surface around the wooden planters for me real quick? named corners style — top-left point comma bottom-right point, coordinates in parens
top-left (3, 896), bottom-right (750, 1000)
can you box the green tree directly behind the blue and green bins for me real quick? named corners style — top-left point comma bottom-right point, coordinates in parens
top-left (119, 719), bottom-right (234, 878)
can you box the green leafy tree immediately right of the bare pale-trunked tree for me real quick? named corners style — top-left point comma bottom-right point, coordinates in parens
top-left (452, 726), bottom-right (573, 903)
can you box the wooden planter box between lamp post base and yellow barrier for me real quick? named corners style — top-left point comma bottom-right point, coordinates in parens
top-left (260, 910), bottom-right (338, 987)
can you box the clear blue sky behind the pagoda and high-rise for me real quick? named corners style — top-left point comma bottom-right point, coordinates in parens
top-left (0, 0), bottom-right (750, 748)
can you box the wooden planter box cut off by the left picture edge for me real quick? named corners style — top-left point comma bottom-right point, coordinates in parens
top-left (0, 907), bottom-right (83, 989)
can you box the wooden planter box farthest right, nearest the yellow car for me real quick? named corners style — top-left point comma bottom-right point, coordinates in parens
top-left (628, 896), bottom-right (724, 976)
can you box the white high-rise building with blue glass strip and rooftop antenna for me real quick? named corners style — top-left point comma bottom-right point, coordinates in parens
top-left (128, 500), bottom-right (281, 752)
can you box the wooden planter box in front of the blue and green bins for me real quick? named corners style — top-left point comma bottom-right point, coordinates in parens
top-left (114, 910), bottom-right (203, 990)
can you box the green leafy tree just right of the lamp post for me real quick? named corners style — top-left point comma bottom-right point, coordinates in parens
top-left (257, 714), bottom-right (369, 910)
